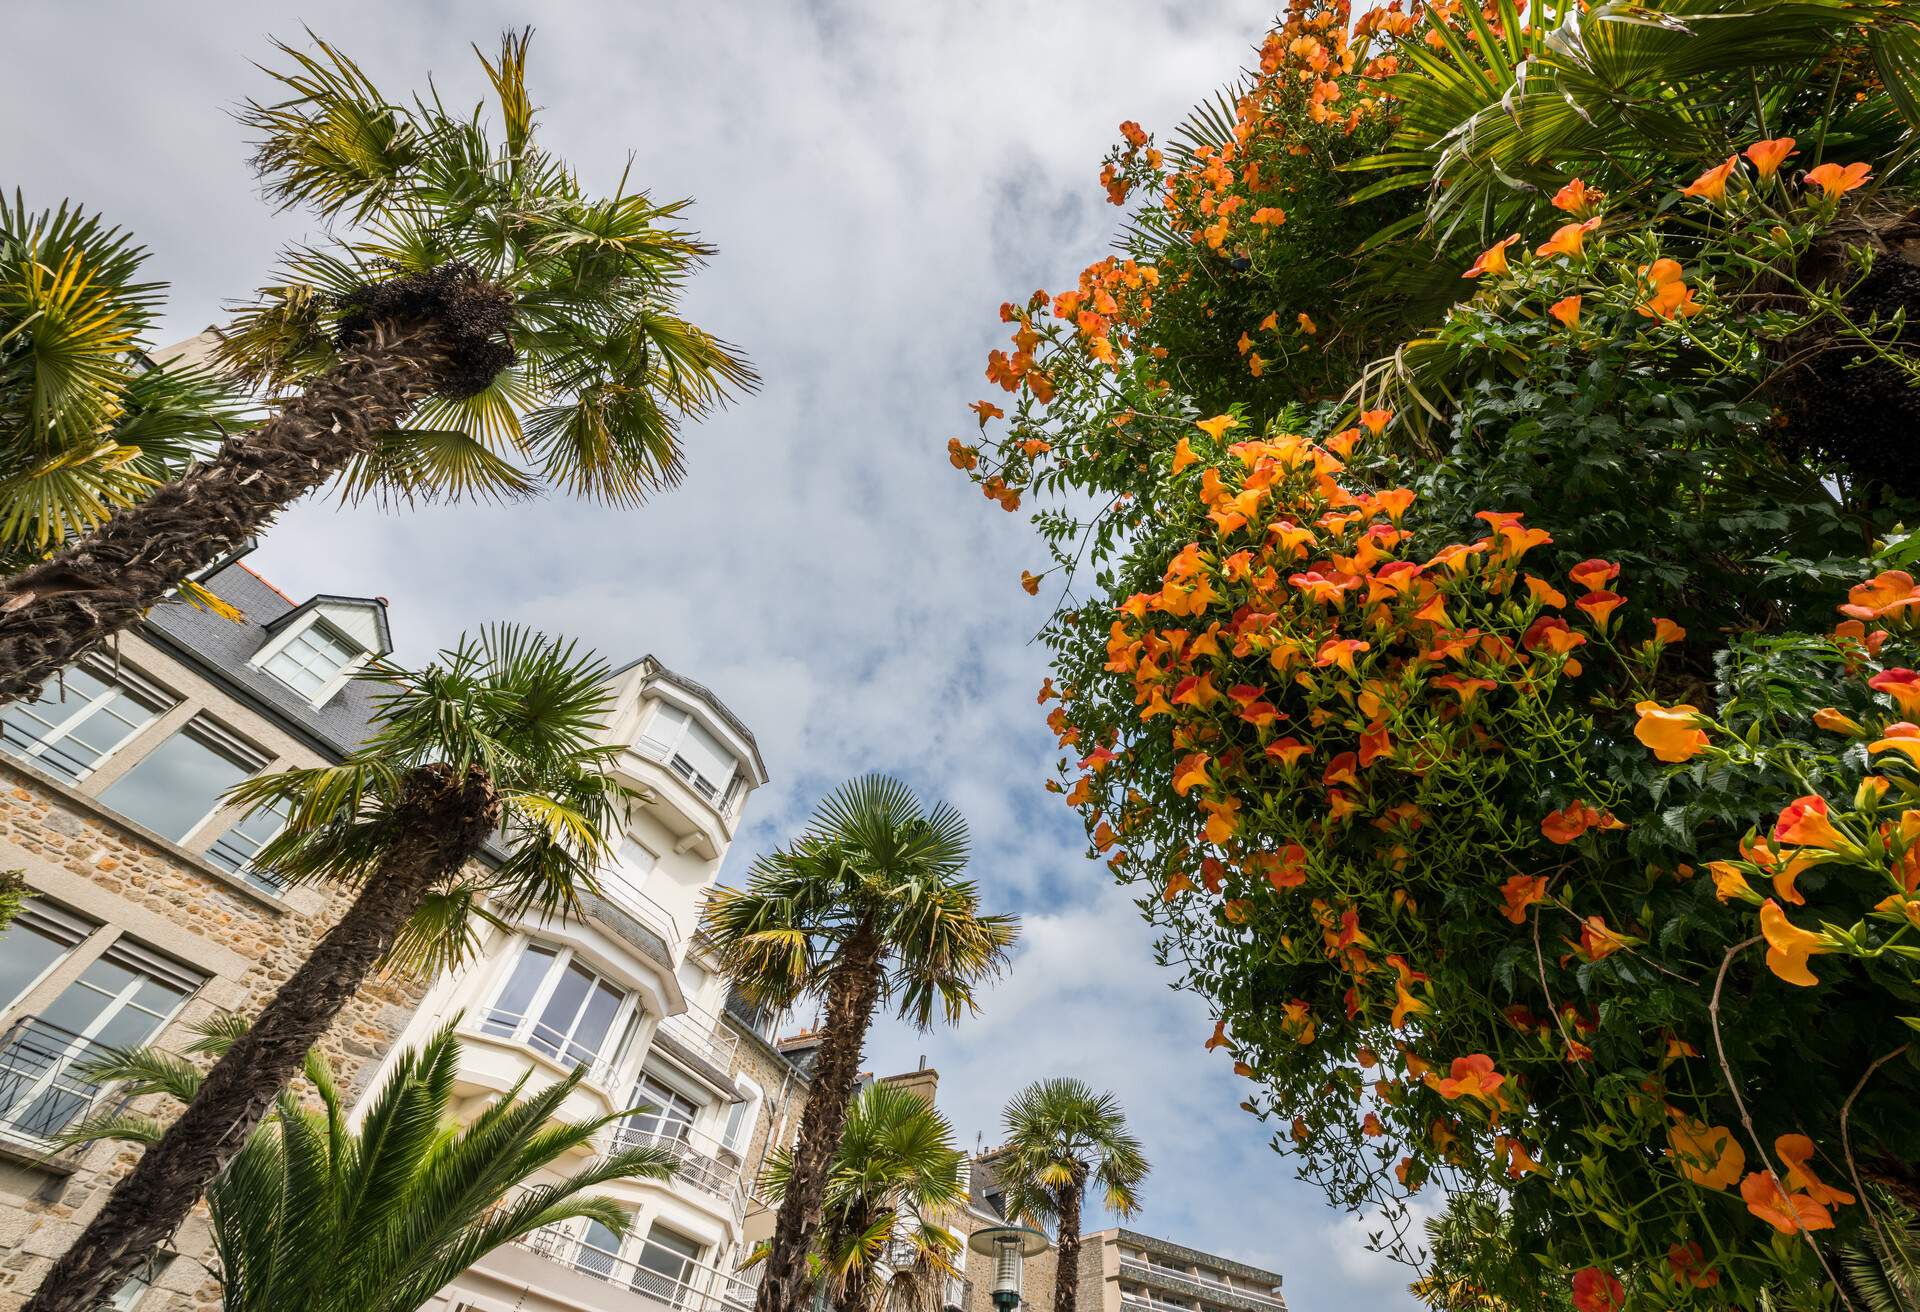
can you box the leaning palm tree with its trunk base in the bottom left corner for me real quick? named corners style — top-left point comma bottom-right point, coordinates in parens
top-left (27, 628), bottom-right (628, 1312)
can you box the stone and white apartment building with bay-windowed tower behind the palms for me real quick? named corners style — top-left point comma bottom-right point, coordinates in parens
top-left (0, 563), bottom-right (810, 1312)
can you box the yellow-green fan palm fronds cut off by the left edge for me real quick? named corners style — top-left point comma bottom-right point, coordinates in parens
top-left (0, 192), bottom-right (246, 574)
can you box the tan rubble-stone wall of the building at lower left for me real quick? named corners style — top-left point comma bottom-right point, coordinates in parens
top-left (0, 757), bottom-right (422, 1312)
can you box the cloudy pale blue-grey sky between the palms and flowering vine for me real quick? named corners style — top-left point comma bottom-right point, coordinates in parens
top-left (0, 0), bottom-right (1415, 1312)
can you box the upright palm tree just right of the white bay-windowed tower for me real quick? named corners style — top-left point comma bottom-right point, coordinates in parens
top-left (703, 774), bottom-right (1020, 1312)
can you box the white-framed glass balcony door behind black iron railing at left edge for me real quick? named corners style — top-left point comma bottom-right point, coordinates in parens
top-left (0, 939), bottom-right (202, 1139)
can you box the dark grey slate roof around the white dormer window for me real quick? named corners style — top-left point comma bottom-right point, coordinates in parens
top-left (144, 563), bottom-right (384, 755)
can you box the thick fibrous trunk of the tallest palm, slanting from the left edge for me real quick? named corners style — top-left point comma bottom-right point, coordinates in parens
top-left (0, 323), bottom-right (445, 703)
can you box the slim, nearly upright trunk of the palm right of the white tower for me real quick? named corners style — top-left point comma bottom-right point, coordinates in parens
top-left (753, 916), bottom-right (881, 1312)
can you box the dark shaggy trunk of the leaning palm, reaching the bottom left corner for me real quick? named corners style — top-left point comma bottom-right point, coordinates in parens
top-left (21, 765), bottom-right (499, 1312)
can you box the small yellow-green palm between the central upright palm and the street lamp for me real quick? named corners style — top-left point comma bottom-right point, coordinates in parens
top-left (753, 1083), bottom-right (966, 1312)
